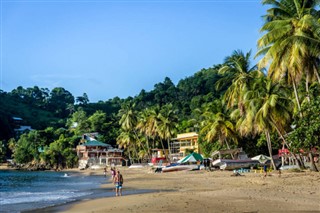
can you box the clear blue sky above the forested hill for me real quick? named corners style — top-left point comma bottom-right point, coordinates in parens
top-left (0, 0), bottom-right (267, 102)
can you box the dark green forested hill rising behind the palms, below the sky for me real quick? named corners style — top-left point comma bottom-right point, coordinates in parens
top-left (0, 66), bottom-right (224, 142)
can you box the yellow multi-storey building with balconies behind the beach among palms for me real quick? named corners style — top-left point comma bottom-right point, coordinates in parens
top-left (170, 132), bottom-right (200, 160)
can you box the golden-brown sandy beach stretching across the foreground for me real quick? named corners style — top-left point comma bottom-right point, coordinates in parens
top-left (60, 167), bottom-right (320, 213)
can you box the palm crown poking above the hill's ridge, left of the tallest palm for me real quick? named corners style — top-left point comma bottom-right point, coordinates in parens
top-left (216, 50), bottom-right (263, 108)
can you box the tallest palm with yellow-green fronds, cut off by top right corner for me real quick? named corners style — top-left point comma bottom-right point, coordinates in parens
top-left (256, 0), bottom-right (320, 110)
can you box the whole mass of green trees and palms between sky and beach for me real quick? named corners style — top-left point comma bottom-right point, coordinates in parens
top-left (0, 0), bottom-right (320, 170)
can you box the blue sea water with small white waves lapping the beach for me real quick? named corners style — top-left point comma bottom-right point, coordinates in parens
top-left (0, 170), bottom-right (110, 212)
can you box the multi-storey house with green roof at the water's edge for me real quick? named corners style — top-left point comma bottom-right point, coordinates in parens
top-left (76, 133), bottom-right (127, 169)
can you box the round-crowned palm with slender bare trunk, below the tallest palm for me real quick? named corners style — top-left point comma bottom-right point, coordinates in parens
top-left (244, 77), bottom-right (292, 169)
